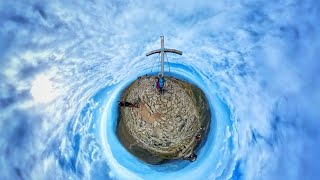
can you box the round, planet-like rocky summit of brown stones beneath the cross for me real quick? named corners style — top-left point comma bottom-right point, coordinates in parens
top-left (117, 76), bottom-right (211, 164)
